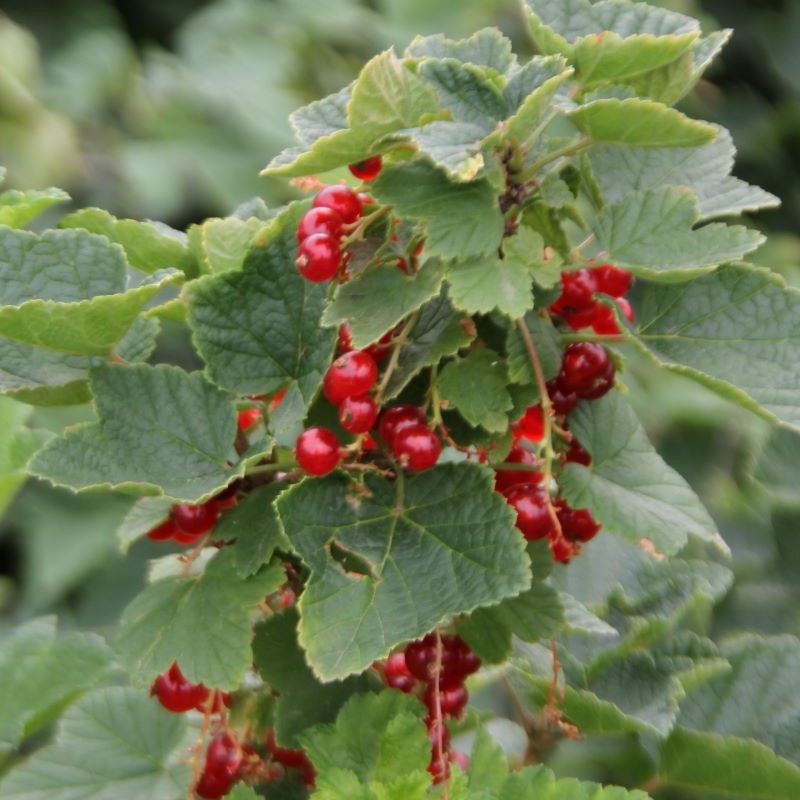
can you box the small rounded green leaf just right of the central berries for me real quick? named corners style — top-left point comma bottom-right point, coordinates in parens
top-left (436, 348), bottom-right (513, 433)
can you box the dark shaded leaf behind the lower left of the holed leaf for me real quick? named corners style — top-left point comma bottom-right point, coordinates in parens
top-left (253, 608), bottom-right (369, 747)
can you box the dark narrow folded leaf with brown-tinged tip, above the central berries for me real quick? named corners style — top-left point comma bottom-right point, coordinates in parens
top-left (384, 291), bottom-right (473, 399)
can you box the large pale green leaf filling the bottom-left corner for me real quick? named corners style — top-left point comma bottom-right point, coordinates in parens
top-left (0, 687), bottom-right (191, 800)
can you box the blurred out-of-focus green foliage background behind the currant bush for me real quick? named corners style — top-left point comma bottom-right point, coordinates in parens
top-left (0, 0), bottom-right (800, 800)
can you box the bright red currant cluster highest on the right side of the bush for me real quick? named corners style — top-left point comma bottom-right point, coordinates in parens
top-left (550, 264), bottom-right (633, 335)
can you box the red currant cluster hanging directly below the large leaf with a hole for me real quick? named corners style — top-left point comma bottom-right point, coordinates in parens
top-left (383, 633), bottom-right (481, 783)
